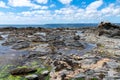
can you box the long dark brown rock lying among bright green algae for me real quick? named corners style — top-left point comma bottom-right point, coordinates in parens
top-left (10, 68), bottom-right (37, 75)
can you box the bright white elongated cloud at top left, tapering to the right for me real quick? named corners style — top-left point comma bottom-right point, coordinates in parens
top-left (8, 0), bottom-right (48, 9)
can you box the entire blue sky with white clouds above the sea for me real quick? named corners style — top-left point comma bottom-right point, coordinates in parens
top-left (0, 0), bottom-right (120, 24)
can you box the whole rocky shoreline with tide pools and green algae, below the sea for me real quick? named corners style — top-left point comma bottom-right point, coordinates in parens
top-left (0, 22), bottom-right (120, 80)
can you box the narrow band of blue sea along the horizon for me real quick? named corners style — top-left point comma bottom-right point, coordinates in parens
top-left (0, 23), bottom-right (120, 28)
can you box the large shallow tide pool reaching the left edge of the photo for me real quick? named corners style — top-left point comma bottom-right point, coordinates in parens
top-left (0, 33), bottom-right (26, 66)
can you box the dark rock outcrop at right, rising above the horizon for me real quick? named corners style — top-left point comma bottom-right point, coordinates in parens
top-left (98, 22), bottom-right (120, 38)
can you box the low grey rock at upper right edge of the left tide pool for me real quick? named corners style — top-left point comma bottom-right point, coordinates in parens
top-left (12, 41), bottom-right (30, 50)
